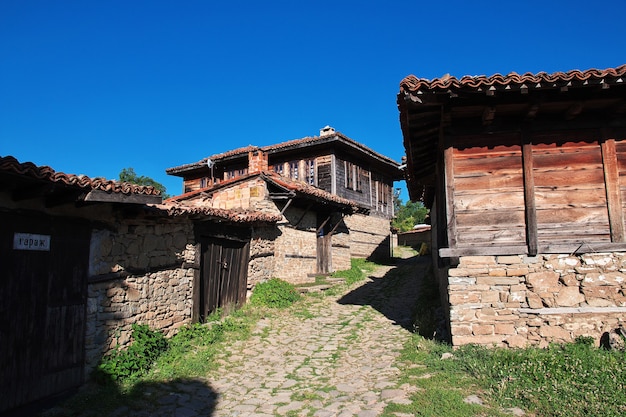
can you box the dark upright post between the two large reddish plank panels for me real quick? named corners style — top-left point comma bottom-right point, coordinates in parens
top-left (522, 131), bottom-right (538, 256)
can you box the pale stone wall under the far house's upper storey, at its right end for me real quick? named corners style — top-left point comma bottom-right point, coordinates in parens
top-left (345, 214), bottom-right (391, 260)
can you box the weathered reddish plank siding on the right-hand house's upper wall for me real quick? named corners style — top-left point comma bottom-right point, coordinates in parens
top-left (447, 130), bottom-right (626, 248)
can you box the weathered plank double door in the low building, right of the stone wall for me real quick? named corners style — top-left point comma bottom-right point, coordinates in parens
top-left (200, 238), bottom-right (250, 320)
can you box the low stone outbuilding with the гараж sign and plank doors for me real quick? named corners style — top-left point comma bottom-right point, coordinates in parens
top-left (0, 157), bottom-right (282, 412)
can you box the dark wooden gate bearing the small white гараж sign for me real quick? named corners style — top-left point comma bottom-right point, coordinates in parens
top-left (0, 213), bottom-right (90, 412)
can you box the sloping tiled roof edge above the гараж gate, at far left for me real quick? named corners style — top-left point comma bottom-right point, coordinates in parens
top-left (0, 156), bottom-right (161, 196)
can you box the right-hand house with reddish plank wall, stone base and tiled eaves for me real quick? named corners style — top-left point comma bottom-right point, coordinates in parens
top-left (397, 65), bottom-right (626, 346)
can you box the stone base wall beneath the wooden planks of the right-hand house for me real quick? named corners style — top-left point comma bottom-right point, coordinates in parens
top-left (447, 253), bottom-right (626, 347)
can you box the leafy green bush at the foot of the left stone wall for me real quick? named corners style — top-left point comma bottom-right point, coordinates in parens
top-left (96, 323), bottom-right (167, 382)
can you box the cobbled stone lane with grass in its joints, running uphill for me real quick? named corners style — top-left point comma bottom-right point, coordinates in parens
top-left (119, 254), bottom-right (427, 417)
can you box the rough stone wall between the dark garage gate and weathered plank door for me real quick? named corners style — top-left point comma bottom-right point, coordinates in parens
top-left (85, 221), bottom-right (197, 372)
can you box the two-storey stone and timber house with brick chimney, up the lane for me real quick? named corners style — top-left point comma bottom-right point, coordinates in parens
top-left (166, 127), bottom-right (402, 283)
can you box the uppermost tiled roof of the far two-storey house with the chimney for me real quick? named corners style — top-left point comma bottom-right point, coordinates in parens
top-left (165, 132), bottom-right (399, 174)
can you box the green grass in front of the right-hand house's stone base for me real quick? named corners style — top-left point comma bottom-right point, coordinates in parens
top-left (385, 334), bottom-right (626, 417)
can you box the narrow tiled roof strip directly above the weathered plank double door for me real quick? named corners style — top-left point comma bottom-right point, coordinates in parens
top-left (147, 203), bottom-right (282, 223)
